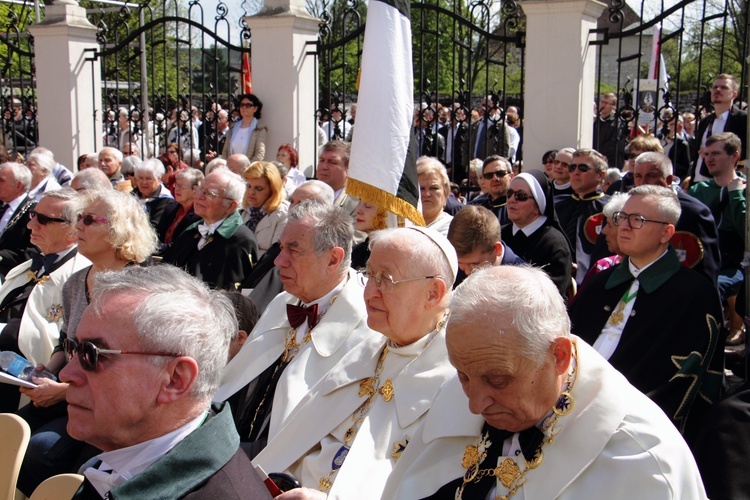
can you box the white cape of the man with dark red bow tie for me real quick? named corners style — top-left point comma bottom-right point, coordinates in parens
top-left (213, 269), bottom-right (381, 439)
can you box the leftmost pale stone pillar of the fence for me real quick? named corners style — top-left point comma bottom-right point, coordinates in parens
top-left (29, 0), bottom-right (102, 169)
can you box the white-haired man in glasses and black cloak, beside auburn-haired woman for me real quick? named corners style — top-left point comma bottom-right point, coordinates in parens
top-left (164, 167), bottom-right (258, 290)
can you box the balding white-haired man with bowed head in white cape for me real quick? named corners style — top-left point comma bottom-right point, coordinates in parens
top-left (383, 266), bottom-right (706, 500)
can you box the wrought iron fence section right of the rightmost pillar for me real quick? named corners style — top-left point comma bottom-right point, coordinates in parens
top-left (590, 0), bottom-right (748, 172)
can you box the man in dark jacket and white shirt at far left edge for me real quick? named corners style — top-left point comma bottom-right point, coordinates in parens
top-left (0, 163), bottom-right (38, 278)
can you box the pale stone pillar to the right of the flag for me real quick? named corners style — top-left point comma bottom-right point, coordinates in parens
top-left (520, 0), bottom-right (605, 169)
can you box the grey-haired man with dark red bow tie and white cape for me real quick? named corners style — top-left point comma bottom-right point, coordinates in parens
top-left (215, 201), bottom-right (374, 456)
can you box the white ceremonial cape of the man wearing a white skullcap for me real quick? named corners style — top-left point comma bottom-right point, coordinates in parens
top-left (253, 330), bottom-right (455, 500)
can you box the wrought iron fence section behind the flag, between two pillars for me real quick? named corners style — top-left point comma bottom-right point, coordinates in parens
top-left (314, 0), bottom-right (525, 181)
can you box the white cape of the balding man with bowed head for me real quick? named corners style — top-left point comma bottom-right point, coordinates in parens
top-left (383, 336), bottom-right (706, 500)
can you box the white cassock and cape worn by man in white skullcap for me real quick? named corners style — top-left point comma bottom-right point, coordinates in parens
top-left (253, 330), bottom-right (455, 500)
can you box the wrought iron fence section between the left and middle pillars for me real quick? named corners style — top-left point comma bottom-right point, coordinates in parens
top-left (89, 0), bottom-right (250, 163)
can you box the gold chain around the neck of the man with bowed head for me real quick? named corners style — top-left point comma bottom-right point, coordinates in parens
top-left (456, 344), bottom-right (578, 500)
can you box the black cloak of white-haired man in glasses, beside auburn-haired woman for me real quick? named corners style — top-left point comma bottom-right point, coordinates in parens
top-left (164, 212), bottom-right (258, 290)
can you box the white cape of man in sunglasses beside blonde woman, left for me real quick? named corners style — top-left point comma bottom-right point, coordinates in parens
top-left (0, 250), bottom-right (91, 365)
